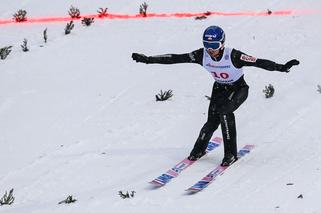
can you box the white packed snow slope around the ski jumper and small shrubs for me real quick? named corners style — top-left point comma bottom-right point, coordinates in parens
top-left (0, 0), bottom-right (321, 213)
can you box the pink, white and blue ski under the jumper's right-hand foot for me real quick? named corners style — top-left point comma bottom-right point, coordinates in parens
top-left (186, 145), bottom-right (254, 193)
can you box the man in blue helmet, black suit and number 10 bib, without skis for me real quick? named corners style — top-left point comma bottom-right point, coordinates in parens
top-left (132, 26), bottom-right (299, 166)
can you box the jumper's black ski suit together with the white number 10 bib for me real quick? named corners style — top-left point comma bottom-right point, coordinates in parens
top-left (148, 47), bottom-right (282, 157)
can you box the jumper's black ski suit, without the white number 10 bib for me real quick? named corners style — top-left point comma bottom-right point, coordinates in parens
top-left (132, 48), bottom-right (299, 160)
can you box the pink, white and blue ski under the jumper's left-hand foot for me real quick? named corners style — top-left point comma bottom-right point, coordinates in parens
top-left (149, 137), bottom-right (222, 187)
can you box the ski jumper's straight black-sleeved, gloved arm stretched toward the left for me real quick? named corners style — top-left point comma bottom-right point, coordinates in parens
top-left (132, 49), bottom-right (203, 64)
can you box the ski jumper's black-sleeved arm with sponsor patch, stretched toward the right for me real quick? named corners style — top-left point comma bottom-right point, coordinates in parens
top-left (232, 49), bottom-right (300, 72)
